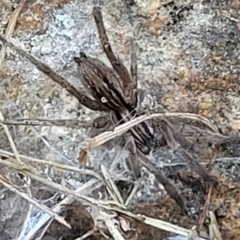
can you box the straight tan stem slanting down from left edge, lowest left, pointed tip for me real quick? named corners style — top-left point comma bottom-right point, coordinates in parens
top-left (0, 175), bottom-right (71, 228)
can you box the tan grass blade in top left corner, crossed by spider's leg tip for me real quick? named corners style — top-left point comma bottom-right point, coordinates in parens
top-left (0, 0), bottom-right (25, 66)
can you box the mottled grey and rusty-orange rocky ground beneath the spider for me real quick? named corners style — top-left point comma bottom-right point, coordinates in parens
top-left (0, 0), bottom-right (240, 240)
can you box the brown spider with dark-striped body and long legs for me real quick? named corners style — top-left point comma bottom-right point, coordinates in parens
top-left (0, 3), bottom-right (217, 210)
